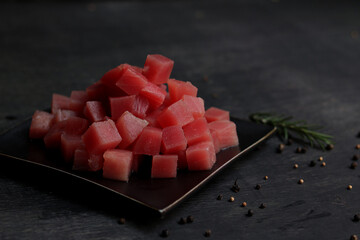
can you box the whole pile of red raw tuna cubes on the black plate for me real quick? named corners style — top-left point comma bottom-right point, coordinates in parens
top-left (29, 54), bottom-right (238, 181)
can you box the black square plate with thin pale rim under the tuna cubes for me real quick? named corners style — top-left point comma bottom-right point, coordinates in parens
top-left (0, 118), bottom-right (276, 214)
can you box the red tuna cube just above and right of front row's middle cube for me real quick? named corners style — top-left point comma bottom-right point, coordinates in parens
top-left (161, 125), bottom-right (187, 154)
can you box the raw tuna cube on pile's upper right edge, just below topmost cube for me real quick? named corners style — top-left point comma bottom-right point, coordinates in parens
top-left (168, 79), bottom-right (198, 102)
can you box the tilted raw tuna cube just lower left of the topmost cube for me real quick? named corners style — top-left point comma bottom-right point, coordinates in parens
top-left (116, 68), bottom-right (148, 95)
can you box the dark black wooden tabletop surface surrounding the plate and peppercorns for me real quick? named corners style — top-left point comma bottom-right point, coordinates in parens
top-left (0, 0), bottom-right (360, 239)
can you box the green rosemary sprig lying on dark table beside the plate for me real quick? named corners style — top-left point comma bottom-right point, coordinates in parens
top-left (249, 113), bottom-right (333, 150)
